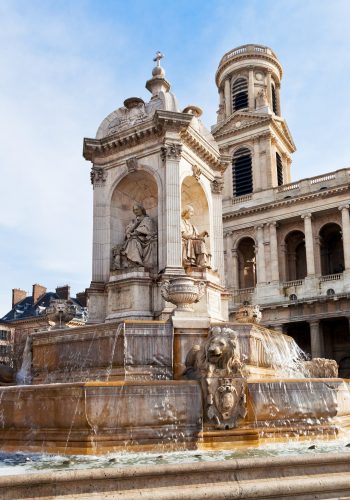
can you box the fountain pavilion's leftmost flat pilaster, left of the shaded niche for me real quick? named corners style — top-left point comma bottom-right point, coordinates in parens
top-left (91, 167), bottom-right (111, 283)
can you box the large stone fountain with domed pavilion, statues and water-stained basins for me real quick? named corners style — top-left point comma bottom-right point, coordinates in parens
top-left (0, 54), bottom-right (350, 498)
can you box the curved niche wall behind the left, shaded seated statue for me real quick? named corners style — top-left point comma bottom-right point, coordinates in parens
top-left (110, 170), bottom-right (158, 247)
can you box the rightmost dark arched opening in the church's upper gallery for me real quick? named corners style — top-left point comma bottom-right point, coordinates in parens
top-left (320, 223), bottom-right (344, 276)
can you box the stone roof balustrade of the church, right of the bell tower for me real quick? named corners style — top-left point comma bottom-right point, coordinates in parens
top-left (274, 168), bottom-right (350, 198)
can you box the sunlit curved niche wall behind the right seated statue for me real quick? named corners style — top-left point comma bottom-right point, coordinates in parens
top-left (181, 175), bottom-right (212, 253)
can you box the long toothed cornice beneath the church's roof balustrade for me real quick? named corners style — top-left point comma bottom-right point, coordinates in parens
top-left (222, 184), bottom-right (350, 222)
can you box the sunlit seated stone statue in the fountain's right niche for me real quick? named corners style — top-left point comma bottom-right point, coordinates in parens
top-left (181, 205), bottom-right (210, 268)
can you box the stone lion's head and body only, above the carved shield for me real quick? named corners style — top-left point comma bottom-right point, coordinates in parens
top-left (184, 326), bottom-right (243, 380)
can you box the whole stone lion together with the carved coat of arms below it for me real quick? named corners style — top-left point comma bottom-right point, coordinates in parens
top-left (184, 326), bottom-right (247, 429)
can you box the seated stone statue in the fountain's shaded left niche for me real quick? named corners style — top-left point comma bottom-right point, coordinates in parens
top-left (112, 203), bottom-right (157, 270)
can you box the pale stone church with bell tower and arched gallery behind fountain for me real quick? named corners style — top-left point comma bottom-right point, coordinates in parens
top-left (212, 45), bottom-right (350, 376)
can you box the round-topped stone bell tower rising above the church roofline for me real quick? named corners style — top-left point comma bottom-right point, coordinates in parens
top-left (212, 44), bottom-right (296, 199)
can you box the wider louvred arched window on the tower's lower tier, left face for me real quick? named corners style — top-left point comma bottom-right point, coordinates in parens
top-left (232, 148), bottom-right (253, 196)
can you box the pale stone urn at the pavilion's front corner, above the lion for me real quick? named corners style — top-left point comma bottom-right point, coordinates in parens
top-left (160, 276), bottom-right (205, 311)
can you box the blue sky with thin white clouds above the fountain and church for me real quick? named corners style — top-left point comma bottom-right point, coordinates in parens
top-left (0, 0), bottom-right (350, 317)
